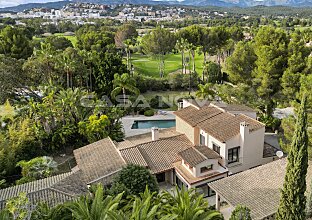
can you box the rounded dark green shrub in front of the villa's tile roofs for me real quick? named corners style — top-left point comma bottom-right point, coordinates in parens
top-left (113, 164), bottom-right (159, 195)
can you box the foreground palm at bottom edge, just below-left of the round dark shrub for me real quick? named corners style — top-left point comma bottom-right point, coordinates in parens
top-left (68, 185), bottom-right (122, 220)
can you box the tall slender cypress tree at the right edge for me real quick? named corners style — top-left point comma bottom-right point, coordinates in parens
top-left (276, 96), bottom-right (308, 220)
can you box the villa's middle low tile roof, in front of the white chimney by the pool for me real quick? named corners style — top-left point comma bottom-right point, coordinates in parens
top-left (131, 135), bottom-right (192, 173)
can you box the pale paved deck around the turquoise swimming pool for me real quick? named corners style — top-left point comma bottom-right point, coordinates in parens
top-left (121, 111), bottom-right (175, 137)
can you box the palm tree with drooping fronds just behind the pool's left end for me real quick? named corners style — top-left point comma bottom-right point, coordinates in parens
top-left (111, 73), bottom-right (140, 106)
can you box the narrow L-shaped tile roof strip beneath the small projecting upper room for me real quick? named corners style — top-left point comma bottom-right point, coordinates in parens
top-left (173, 161), bottom-right (228, 184)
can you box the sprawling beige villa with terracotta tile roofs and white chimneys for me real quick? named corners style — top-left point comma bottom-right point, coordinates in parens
top-left (0, 100), bottom-right (279, 209)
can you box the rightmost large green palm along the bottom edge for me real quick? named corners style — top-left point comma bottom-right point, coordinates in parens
top-left (164, 187), bottom-right (224, 220)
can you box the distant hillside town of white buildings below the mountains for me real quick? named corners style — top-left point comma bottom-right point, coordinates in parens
top-left (0, 3), bottom-right (227, 22)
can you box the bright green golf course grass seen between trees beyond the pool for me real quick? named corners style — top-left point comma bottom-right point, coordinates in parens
top-left (132, 54), bottom-right (204, 77)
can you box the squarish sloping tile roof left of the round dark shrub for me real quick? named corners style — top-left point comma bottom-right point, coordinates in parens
top-left (74, 138), bottom-right (126, 183)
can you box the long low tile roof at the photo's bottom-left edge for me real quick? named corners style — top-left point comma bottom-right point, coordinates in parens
top-left (0, 172), bottom-right (75, 210)
